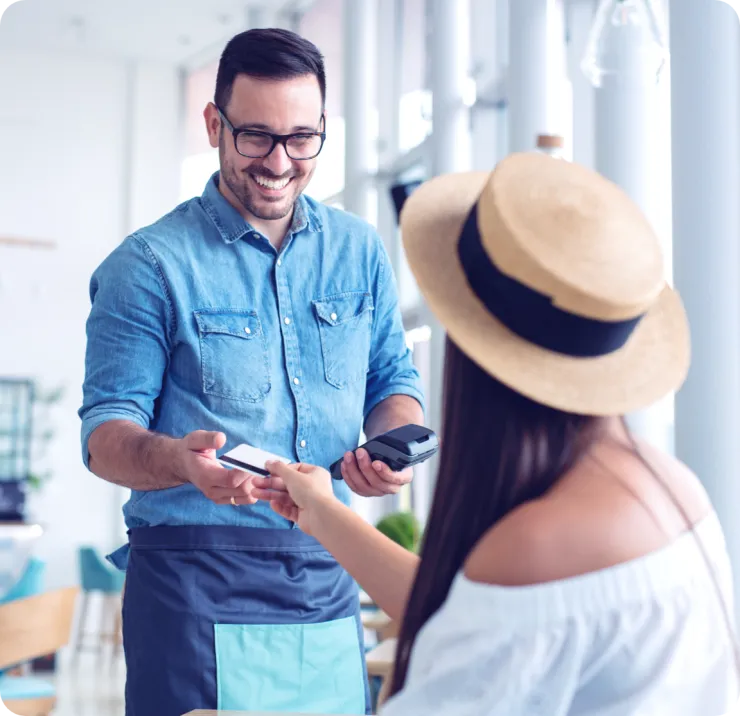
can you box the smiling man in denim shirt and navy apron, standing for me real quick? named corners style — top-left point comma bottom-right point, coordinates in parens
top-left (80, 29), bottom-right (423, 716)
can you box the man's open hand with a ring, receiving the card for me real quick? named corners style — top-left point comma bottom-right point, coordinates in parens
top-left (174, 430), bottom-right (257, 505)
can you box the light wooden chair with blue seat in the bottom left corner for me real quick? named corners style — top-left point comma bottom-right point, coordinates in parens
top-left (0, 587), bottom-right (79, 716)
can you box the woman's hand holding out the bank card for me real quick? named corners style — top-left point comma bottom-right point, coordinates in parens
top-left (252, 461), bottom-right (336, 534)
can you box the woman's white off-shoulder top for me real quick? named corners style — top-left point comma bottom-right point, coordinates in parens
top-left (381, 513), bottom-right (740, 716)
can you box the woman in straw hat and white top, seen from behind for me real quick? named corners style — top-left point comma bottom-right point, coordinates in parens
top-left (255, 154), bottom-right (737, 716)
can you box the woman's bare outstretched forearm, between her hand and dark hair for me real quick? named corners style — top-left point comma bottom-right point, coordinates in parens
top-left (311, 499), bottom-right (419, 621)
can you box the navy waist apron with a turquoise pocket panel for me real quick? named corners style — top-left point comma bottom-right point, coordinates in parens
top-left (123, 526), bottom-right (371, 716)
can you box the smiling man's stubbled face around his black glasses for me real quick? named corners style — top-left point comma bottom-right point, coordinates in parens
top-left (205, 75), bottom-right (322, 220)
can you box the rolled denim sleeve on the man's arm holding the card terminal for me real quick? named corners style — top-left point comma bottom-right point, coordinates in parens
top-left (364, 238), bottom-right (425, 418)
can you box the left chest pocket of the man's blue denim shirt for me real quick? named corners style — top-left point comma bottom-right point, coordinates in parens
top-left (194, 309), bottom-right (271, 403)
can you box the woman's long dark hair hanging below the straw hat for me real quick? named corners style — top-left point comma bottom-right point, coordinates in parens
top-left (391, 339), bottom-right (602, 694)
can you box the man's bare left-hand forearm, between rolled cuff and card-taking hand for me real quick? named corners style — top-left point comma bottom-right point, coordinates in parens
top-left (88, 420), bottom-right (183, 490)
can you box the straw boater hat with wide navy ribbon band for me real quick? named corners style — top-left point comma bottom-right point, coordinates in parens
top-left (401, 152), bottom-right (690, 415)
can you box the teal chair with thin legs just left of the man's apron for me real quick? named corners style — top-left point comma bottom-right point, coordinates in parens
top-left (74, 547), bottom-right (126, 661)
